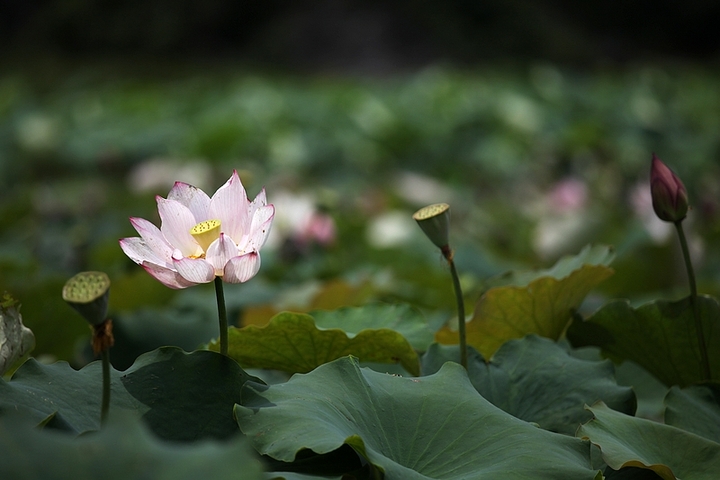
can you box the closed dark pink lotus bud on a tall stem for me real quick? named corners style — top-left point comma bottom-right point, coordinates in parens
top-left (650, 153), bottom-right (688, 223)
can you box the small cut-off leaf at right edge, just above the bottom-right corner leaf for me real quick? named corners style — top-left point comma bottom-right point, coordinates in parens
top-left (665, 382), bottom-right (720, 444)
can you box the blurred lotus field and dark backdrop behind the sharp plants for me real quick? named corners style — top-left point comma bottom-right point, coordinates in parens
top-left (0, 0), bottom-right (720, 368)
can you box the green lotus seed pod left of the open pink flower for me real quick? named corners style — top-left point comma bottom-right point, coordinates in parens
top-left (62, 272), bottom-right (110, 325)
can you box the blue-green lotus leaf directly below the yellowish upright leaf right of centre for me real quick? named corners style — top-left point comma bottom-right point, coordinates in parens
top-left (422, 335), bottom-right (636, 435)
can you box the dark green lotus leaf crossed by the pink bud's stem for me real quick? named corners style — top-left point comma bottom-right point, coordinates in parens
top-left (567, 296), bottom-right (720, 387)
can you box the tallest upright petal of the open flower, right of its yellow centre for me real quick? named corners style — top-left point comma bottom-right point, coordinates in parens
top-left (208, 170), bottom-right (250, 239)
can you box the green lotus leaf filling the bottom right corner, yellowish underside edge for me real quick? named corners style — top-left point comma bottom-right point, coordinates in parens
top-left (577, 403), bottom-right (720, 480)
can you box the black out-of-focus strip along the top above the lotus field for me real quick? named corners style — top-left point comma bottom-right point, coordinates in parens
top-left (0, 0), bottom-right (720, 73)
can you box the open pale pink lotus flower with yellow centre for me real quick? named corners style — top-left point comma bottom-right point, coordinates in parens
top-left (120, 171), bottom-right (275, 288)
